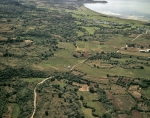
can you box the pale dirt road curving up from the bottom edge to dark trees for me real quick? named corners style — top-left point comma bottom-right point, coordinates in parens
top-left (31, 77), bottom-right (52, 118)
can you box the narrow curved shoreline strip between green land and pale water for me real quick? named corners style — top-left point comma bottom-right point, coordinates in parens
top-left (83, 3), bottom-right (150, 23)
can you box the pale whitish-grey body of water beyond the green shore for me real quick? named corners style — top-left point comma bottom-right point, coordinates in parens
top-left (84, 0), bottom-right (150, 22)
